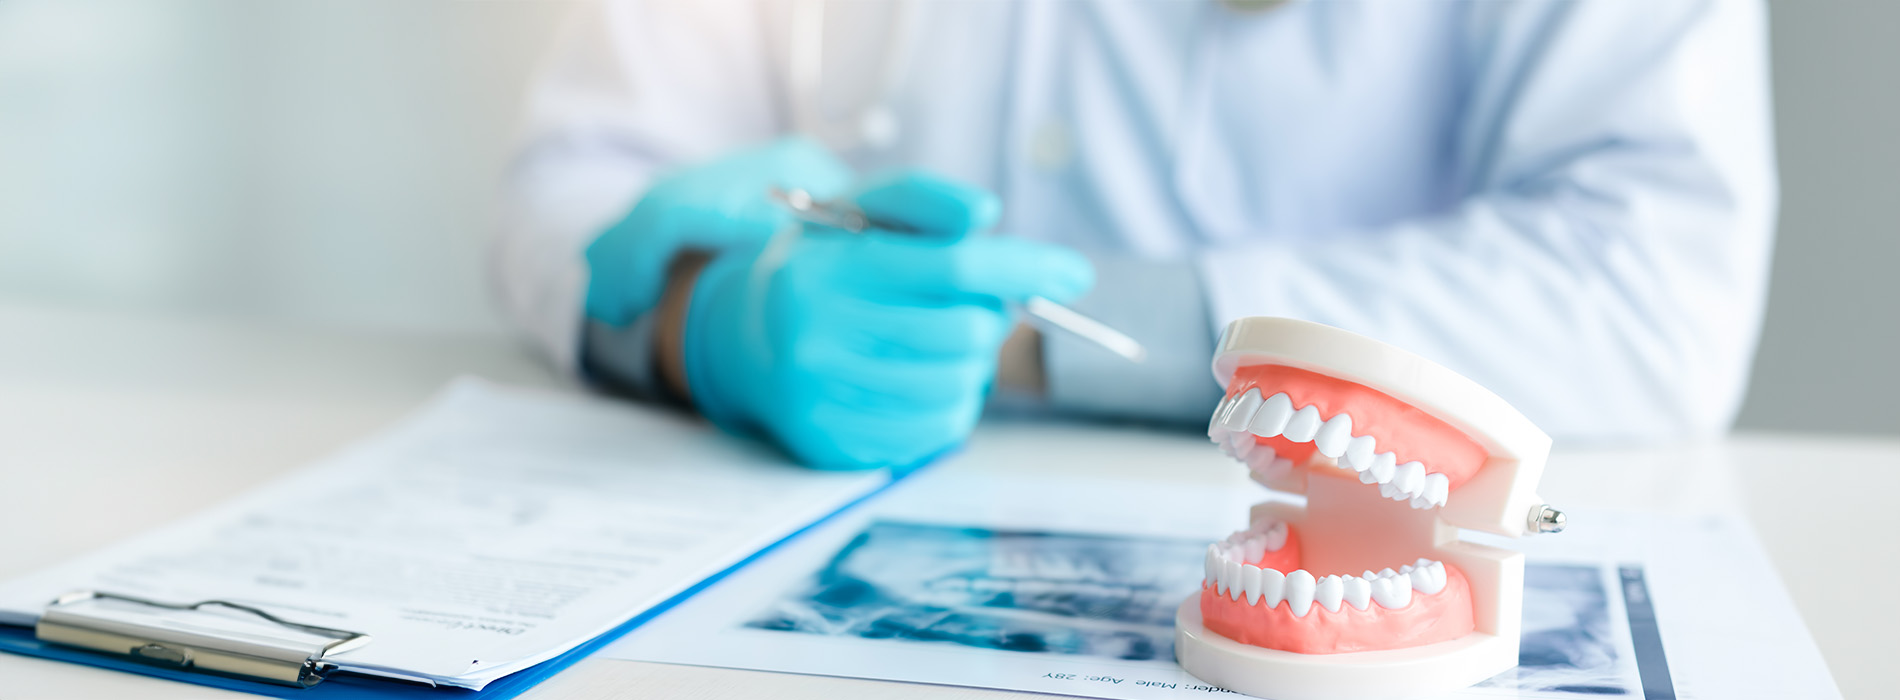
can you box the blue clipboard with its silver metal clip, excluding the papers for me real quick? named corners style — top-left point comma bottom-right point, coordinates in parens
top-left (0, 468), bottom-right (922, 700)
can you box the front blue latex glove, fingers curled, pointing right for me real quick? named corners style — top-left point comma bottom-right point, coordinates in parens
top-left (684, 175), bottom-right (1094, 468)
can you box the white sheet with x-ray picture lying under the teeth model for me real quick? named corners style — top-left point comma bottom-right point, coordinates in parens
top-left (602, 462), bottom-right (1837, 700)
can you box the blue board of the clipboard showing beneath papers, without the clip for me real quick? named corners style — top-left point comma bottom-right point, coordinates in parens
top-left (0, 470), bottom-right (922, 700)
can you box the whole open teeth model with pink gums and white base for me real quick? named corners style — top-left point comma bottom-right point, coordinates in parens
top-left (1174, 318), bottom-right (1562, 700)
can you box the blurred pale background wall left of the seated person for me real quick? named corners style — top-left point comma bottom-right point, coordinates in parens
top-left (0, 0), bottom-right (570, 331)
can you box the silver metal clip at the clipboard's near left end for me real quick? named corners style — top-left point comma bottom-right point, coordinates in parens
top-left (34, 592), bottom-right (371, 689)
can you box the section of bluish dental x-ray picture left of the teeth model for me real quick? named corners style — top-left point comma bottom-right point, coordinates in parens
top-left (747, 521), bottom-right (1207, 660)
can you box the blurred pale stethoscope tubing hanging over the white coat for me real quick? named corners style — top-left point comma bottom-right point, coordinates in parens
top-left (787, 0), bottom-right (1290, 150)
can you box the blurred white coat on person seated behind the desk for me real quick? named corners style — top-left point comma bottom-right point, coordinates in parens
top-left (494, 0), bottom-right (1777, 438)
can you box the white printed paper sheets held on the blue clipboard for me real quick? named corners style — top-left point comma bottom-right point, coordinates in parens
top-left (0, 379), bottom-right (889, 689)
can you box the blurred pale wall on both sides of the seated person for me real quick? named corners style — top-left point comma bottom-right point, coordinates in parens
top-left (0, 0), bottom-right (1900, 434)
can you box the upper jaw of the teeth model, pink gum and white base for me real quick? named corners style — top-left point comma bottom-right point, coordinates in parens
top-left (1208, 318), bottom-right (1556, 536)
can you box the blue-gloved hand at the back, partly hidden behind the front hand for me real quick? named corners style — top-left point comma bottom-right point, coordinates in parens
top-left (587, 137), bottom-right (853, 325)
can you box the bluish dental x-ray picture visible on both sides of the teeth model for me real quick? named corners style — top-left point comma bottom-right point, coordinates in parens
top-left (745, 521), bottom-right (1642, 698)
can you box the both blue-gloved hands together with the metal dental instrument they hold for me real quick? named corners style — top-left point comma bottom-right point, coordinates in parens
top-left (587, 139), bottom-right (1140, 468)
